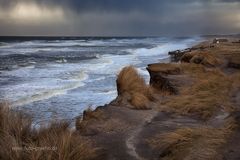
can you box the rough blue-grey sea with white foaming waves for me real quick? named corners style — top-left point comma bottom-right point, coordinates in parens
top-left (0, 36), bottom-right (203, 122)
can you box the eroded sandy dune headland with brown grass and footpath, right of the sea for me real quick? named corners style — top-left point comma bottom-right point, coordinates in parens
top-left (0, 39), bottom-right (240, 160)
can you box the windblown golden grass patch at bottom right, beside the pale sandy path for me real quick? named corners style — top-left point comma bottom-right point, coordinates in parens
top-left (147, 127), bottom-right (232, 160)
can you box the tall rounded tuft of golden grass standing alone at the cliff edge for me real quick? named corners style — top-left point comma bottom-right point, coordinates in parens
top-left (117, 66), bottom-right (154, 109)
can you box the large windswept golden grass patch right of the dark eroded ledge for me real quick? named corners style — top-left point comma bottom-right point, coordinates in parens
top-left (162, 64), bottom-right (232, 119)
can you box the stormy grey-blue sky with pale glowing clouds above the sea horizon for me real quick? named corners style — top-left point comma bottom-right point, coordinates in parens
top-left (0, 0), bottom-right (240, 36)
